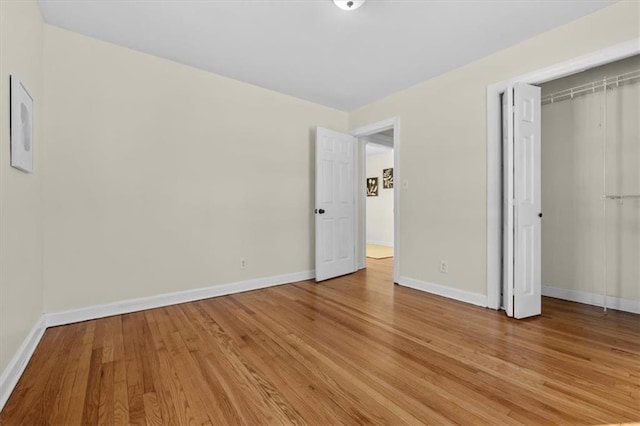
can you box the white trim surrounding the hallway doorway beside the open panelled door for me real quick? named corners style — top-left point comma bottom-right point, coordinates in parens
top-left (351, 117), bottom-right (401, 283)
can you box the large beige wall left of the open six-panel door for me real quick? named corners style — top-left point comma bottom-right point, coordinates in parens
top-left (44, 26), bottom-right (347, 312)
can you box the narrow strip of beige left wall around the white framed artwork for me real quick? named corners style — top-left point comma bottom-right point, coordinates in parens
top-left (0, 1), bottom-right (46, 373)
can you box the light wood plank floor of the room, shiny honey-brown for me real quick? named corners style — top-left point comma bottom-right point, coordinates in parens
top-left (0, 259), bottom-right (640, 425)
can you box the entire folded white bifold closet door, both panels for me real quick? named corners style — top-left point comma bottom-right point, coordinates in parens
top-left (503, 83), bottom-right (542, 318)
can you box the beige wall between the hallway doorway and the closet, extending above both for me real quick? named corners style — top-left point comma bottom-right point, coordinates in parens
top-left (349, 1), bottom-right (640, 294)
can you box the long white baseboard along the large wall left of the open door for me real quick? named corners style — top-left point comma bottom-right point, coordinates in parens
top-left (46, 271), bottom-right (315, 327)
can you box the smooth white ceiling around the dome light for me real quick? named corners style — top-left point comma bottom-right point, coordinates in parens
top-left (40, 0), bottom-right (613, 111)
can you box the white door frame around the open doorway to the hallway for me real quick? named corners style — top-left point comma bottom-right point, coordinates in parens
top-left (350, 117), bottom-right (401, 283)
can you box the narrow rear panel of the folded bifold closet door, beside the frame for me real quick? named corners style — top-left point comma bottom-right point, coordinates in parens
top-left (502, 86), bottom-right (514, 317)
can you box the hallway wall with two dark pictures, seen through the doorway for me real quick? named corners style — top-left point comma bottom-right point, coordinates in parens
top-left (367, 150), bottom-right (393, 247)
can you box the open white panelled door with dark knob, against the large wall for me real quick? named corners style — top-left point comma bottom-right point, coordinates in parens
top-left (315, 127), bottom-right (356, 281)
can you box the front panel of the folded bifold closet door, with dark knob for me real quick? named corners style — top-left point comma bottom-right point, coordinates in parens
top-left (513, 83), bottom-right (542, 318)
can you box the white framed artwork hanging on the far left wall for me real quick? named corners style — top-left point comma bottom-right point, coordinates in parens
top-left (10, 76), bottom-right (33, 173)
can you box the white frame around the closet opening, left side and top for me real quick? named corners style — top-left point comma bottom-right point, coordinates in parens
top-left (487, 38), bottom-right (640, 309)
